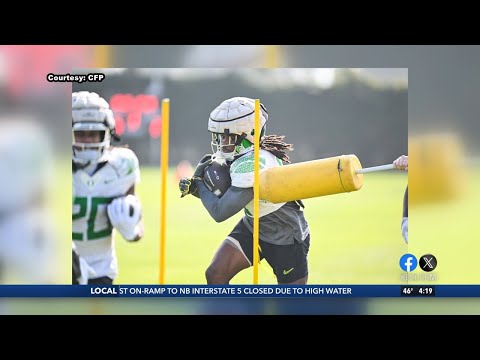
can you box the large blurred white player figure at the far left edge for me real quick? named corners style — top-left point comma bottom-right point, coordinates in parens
top-left (0, 119), bottom-right (57, 284)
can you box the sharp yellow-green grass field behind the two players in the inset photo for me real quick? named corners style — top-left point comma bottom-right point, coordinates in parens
top-left (116, 167), bottom-right (407, 284)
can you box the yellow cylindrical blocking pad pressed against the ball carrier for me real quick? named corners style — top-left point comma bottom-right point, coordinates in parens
top-left (260, 155), bottom-right (363, 203)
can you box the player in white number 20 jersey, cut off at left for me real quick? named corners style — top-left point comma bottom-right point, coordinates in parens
top-left (72, 91), bottom-right (143, 284)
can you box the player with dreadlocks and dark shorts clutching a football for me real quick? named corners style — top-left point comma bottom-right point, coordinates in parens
top-left (179, 97), bottom-right (310, 284)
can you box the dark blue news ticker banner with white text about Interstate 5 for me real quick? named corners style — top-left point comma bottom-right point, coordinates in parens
top-left (0, 285), bottom-right (480, 298)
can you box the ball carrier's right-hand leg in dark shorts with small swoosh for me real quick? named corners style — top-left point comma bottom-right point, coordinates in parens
top-left (262, 235), bottom-right (310, 285)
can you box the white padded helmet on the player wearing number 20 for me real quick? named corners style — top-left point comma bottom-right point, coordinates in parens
top-left (72, 91), bottom-right (116, 165)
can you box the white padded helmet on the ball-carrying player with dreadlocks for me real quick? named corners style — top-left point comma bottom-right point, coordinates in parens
top-left (208, 97), bottom-right (268, 160)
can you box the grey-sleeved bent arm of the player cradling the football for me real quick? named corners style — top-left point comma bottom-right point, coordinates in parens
top-left (195, 180), bottom-right (253, 222)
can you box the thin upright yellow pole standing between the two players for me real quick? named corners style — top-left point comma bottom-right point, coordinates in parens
top-left (160, 99), bottom-right (170, 285)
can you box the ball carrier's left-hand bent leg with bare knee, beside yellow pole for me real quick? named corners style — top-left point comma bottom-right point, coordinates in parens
top-left (205, 220), bottom-right (252, 285)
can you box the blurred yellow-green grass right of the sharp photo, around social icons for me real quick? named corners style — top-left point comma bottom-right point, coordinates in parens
top-left (408, 169), bottom-right (480, 284)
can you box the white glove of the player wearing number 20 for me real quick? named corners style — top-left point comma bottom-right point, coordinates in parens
top-left (107, 195), bottom-right (142, 241)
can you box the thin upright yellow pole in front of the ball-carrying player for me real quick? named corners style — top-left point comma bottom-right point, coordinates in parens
top-left (253, 99), bottom-right (260, 285)
